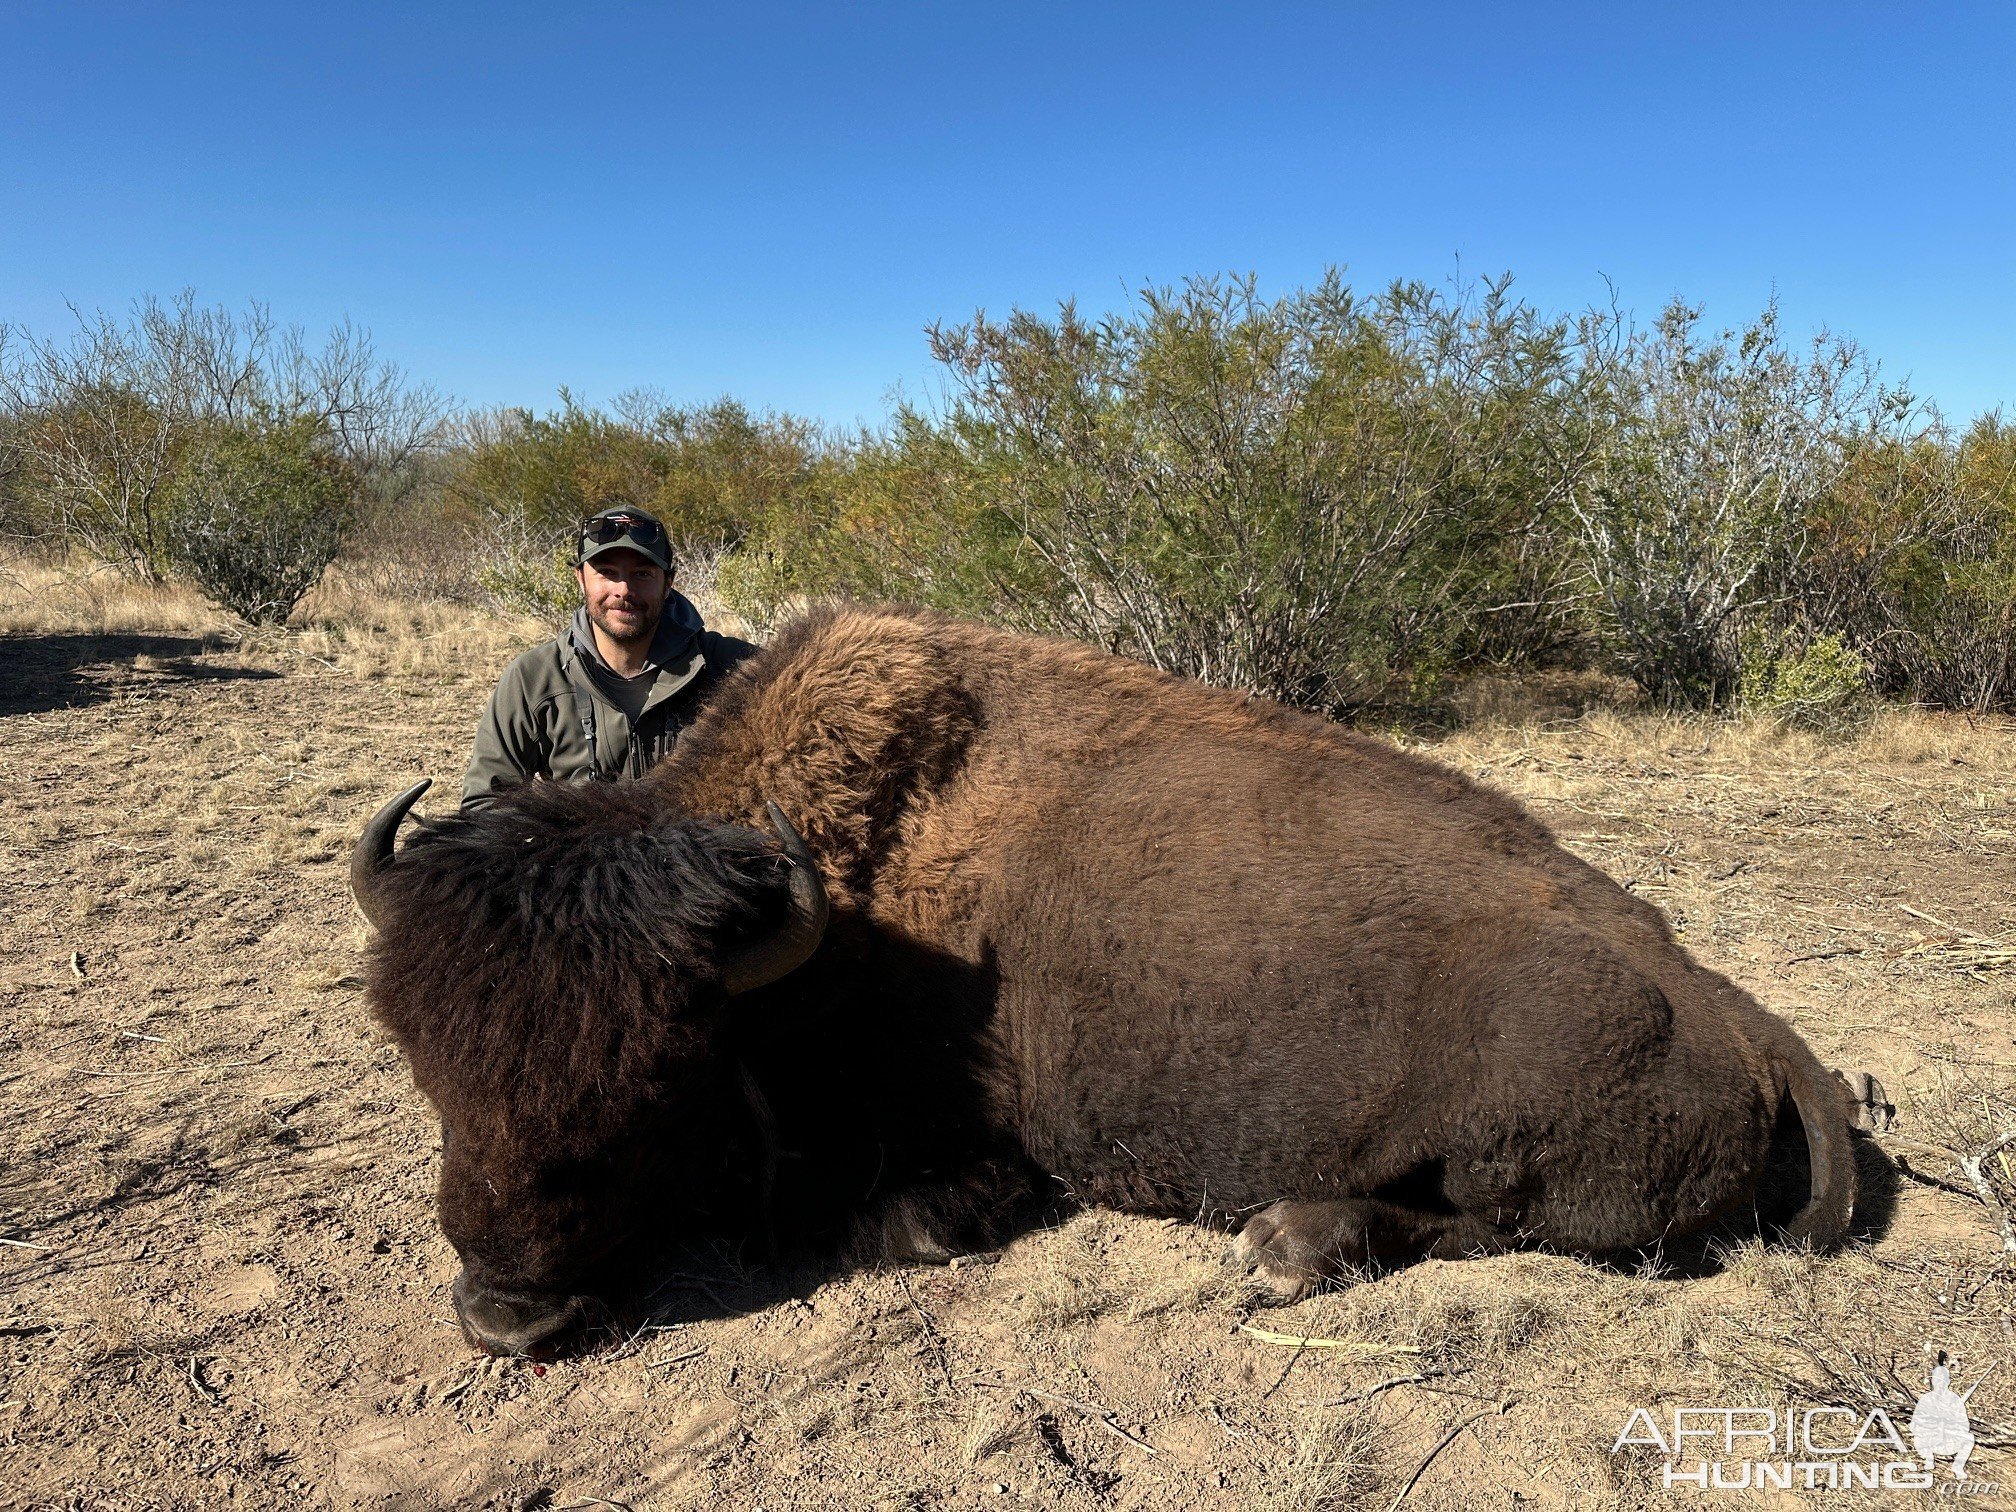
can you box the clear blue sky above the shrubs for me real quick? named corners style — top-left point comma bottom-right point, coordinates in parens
top-left (0, 0), bottom-right (2016, 423)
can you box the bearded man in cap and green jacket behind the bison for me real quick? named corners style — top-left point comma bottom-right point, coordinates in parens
top-left (462, 508), bottom-right (756, 808)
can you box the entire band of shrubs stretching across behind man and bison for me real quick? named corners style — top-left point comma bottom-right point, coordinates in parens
top-left (0, 272), bottom-right (2016, 724)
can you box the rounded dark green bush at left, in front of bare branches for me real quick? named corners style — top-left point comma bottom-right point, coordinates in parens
top-left (163, 417), bottom-right (359, 625)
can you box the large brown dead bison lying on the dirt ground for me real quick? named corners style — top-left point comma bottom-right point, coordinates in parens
top-left (353, 609), bottom-right (1855, 1353)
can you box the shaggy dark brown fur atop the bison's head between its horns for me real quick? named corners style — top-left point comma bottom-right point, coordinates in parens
top-left (371, 782), bottom-right (786, 1137)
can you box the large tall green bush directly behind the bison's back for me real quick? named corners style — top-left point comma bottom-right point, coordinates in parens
top-left (724, 274), bottom-right (1574, 710)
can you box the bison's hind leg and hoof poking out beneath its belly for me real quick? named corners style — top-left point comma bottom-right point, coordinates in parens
top-left (1236, 1198), bottom-right (1504, 1302)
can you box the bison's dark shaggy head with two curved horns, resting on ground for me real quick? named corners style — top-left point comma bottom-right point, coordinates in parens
top-left (351, 782), bottom-right (827, 1355)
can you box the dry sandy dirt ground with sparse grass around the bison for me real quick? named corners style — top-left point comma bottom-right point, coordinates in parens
top-left (0, 572), bottom-right (2016, 1512)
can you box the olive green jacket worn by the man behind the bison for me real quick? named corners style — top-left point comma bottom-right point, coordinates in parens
top-left (462, 593), bottom-right (756, 808)
